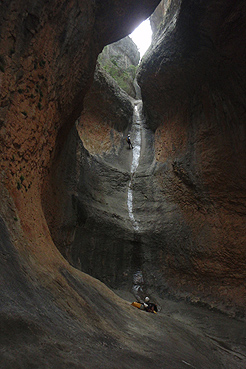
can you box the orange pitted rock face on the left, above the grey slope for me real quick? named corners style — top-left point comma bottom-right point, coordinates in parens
top-left (0, 0), bottom-right (158, 320)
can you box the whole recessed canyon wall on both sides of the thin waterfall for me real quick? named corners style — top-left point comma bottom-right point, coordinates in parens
top-left (43, 2), bottom-right (245, 317)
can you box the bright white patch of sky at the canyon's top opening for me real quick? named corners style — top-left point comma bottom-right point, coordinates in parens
top-left (129, 19), bottom-right (152, 59)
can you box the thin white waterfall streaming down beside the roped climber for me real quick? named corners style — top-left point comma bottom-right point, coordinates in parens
top-left (127, 100), bottom-right (142, 232)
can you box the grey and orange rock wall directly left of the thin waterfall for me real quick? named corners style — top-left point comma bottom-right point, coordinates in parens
top-left (43, 65), bottom-right (133, 281)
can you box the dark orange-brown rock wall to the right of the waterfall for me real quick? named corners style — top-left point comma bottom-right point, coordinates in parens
top-left (138, 1), bottom-right (246, 315)
